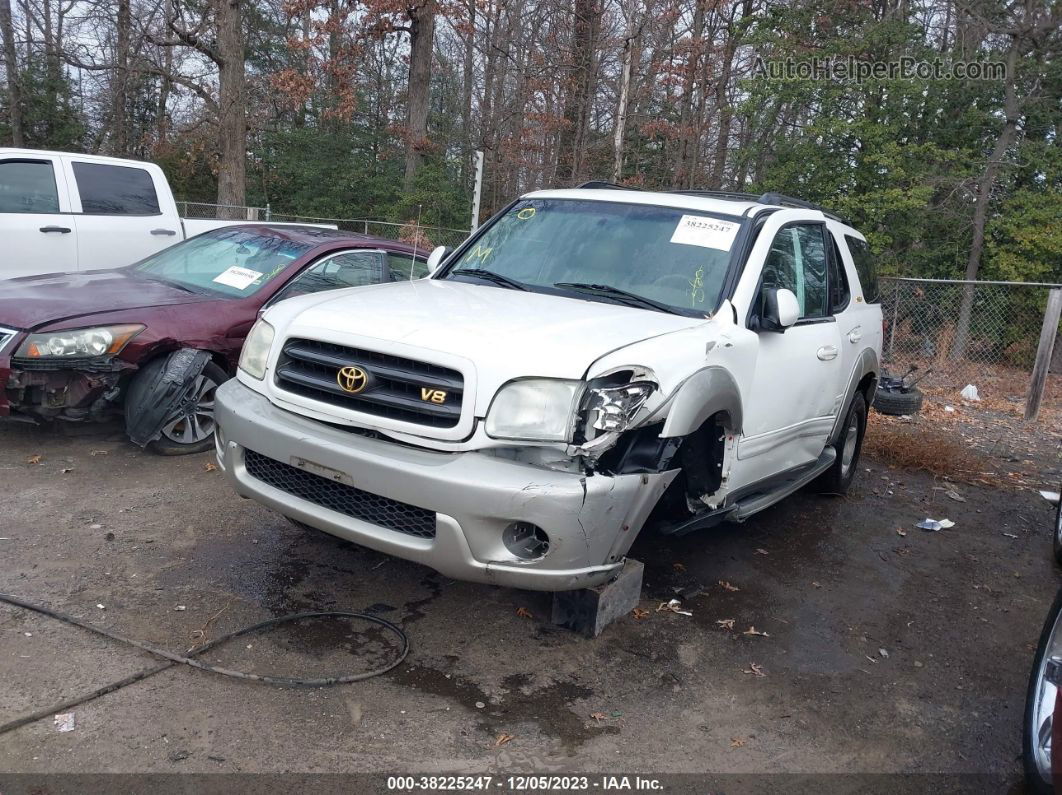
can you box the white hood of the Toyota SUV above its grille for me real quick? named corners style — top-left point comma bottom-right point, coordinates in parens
top-left (267, 279), bottom-right (707, 416)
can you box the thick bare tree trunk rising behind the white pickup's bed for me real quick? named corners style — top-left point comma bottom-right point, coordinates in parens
top-left (213, 0), bottom-right (247, 211)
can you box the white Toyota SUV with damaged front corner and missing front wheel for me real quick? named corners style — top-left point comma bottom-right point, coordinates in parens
top-left (217, 184), bottom-right (881, 590)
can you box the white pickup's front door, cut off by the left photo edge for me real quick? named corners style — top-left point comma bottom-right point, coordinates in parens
top-left (0, 152), bottom-right (78, 279)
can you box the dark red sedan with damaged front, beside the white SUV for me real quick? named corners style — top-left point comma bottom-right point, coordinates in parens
top-left (0, 224), bottom-right (427, 455)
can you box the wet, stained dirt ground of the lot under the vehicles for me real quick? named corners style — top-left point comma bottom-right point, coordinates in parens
top-left (0, 425), bottom-right (1059, 787)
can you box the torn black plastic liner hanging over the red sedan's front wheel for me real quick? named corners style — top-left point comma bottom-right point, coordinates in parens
top-left (125, 348), bottom-right (211, 447)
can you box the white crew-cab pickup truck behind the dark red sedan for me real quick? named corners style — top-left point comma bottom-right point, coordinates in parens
top-left (0, 149), bottom-right (261, 279)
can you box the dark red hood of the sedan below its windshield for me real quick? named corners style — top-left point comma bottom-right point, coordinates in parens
top-left (0, 267), bottom-right (213, 329)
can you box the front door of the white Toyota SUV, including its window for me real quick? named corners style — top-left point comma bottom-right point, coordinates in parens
top-left (738, 213), bottom-right (842, 480)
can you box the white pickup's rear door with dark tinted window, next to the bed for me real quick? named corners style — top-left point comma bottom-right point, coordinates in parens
top-left (64, 156), bottom-right (181, 271)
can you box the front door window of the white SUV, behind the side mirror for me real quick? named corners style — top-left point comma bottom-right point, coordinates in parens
top-left (764, 224), bottom-right (828, 319)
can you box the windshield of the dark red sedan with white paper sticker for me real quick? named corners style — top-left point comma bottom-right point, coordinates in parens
top-left (133, 228), bottom-right (310, 298)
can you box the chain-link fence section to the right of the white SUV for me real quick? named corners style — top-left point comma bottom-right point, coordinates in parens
top-left (880, 278), bottom-right (1062, 416)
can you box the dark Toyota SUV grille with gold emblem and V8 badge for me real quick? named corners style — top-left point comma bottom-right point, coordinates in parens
top-left (276, 339), bottom-right (464, 428)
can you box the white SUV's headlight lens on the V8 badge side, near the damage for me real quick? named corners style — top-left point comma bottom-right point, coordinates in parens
top-left (486, 378), bottom-right (582, 442)
